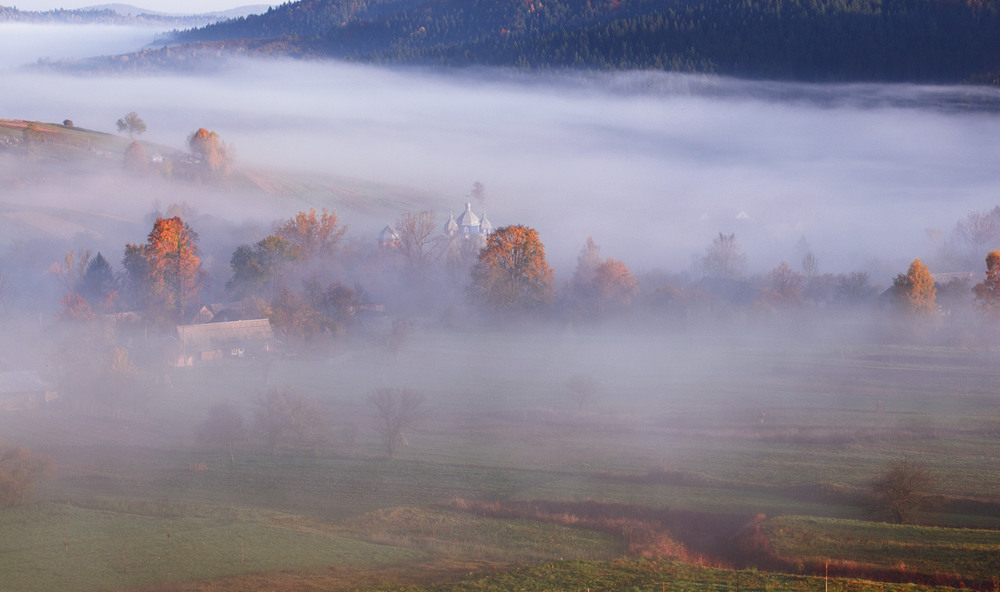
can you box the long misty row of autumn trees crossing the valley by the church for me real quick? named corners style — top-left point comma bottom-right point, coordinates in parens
top-left (43, 200), bottom-right (1000, 347)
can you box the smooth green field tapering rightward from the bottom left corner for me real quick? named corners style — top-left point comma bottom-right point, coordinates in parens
top-left (0, 503), bottom-right (421, 592)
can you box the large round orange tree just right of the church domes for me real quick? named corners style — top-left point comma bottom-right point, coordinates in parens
top-left (469, 225), bottom-right (553, 312)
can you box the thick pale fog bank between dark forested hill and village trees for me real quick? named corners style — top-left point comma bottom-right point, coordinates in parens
top-left (2, 33), bottom-right (1000, 285)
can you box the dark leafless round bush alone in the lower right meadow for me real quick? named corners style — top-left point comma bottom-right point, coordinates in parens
top-left (869, 458), bottom-right (936, 524)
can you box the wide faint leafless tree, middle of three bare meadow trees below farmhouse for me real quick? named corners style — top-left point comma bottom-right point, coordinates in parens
top-left (254, 388), bottom-right (330, 455)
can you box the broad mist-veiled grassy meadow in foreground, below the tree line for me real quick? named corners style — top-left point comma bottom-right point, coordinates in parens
top-left (0, 326), bottom-right (1000, 591)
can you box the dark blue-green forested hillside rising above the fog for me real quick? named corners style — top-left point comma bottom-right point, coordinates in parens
top-left (177, 0), bottom-right (1000, 82)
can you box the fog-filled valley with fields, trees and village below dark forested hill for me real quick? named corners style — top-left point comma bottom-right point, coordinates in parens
top-left (0, 9), bottom-right (1000, 592)
